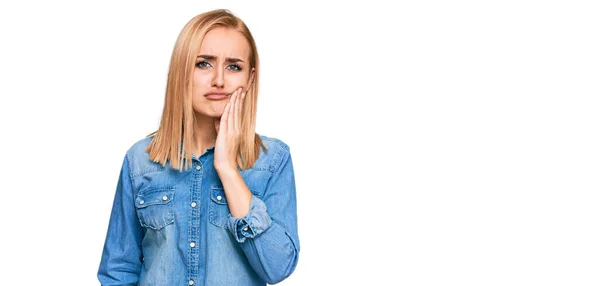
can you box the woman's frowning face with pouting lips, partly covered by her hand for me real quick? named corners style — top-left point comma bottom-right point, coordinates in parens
top-left (192, 27), bottom-right (253, 118)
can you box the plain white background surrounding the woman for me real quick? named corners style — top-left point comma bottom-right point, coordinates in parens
top-left (0, 0), bottom-right (600, 286)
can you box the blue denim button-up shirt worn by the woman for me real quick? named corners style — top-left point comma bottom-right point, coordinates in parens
top-left (98, 135), bottom-right (300, 286)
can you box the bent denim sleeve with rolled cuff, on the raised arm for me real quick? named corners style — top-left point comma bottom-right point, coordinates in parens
top-left (227, 145), bottom-right (300, 284)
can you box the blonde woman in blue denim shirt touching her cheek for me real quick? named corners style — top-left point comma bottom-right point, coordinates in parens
top-left (98, 10), bottom-right (300, 285)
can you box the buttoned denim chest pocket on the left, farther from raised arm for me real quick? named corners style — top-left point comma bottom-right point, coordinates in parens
top-left (135, 187), bottom-right (175, 230)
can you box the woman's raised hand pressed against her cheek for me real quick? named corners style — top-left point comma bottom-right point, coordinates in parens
top-left (214, 87), bottom-right (246, 171)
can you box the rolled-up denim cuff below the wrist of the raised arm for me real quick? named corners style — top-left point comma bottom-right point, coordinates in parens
top-left (227, 194), bottom-right (273, 243)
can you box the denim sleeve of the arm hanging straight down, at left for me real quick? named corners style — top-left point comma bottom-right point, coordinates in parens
top-left (98, 155), bottom-right (143, 285)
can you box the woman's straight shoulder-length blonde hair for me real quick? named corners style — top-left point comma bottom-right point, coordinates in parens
top-left (146, 9), bottom-right (267, 171)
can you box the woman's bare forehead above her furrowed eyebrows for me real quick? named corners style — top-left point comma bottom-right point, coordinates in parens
top-left (200, 27), bottom-right (250, 60)
